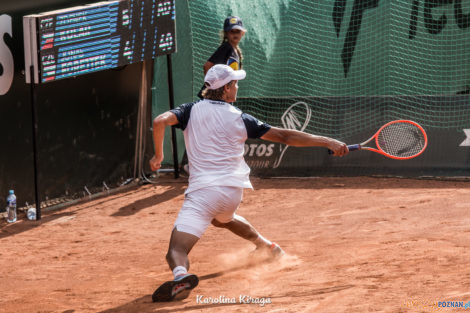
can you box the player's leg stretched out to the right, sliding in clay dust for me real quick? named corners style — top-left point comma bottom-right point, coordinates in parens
top-left (212, 214), bottom-right (284, 257)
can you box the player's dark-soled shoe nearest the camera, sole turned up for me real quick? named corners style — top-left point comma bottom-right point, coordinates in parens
top-left (152, 274), bottom-right (199, 302)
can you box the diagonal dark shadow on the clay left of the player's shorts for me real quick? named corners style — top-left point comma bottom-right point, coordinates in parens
top-left (111, 184), bottom-right (186, 217)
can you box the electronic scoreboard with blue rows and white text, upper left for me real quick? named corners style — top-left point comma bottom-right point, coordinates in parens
top-left (23, 0), bottom-right (176, 83)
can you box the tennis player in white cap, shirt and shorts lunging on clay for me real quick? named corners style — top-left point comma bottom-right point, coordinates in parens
top-left (150, 64), bottom-right (349, 302)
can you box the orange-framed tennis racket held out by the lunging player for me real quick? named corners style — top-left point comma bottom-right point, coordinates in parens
top-left (328, 120), bottom-right (428, 160)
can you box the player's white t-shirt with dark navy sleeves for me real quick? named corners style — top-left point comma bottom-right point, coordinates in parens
top-left (171, 99), bottom-right (271, 193)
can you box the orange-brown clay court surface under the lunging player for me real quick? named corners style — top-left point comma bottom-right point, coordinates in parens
top-left (0, 177), bottom-right (470, 313)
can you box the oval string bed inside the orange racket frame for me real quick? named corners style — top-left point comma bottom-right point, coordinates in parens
top-left (377, 122), bottom-right (426, 158)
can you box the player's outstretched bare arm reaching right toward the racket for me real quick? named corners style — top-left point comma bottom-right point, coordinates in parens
top-left (260, 127), bottom-right (349, 156)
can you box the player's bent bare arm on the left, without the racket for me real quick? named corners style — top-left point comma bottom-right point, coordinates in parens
top-left (150, 111), bottom-right (178, 171)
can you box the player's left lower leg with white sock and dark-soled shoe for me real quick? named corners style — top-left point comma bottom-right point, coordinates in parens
top-left (152, 228), bottom-right (199, 302)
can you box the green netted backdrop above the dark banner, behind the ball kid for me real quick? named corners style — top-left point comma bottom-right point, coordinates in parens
top-left (188, 0), bottom-right (470, 98)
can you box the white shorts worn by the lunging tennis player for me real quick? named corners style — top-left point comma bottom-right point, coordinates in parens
top-left (175, 186), bottom-right (243, 238)
